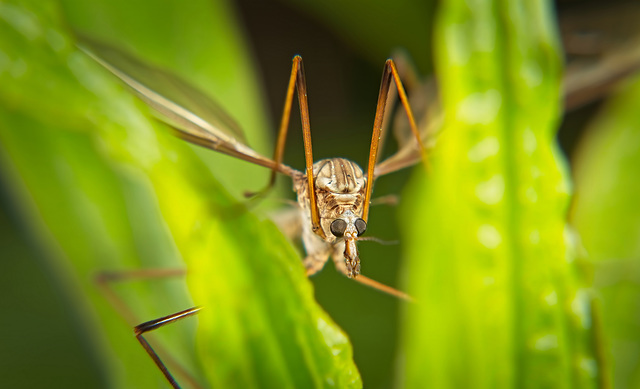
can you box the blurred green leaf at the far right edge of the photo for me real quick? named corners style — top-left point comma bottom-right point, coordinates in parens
top-left (572, 77), bottom-right (640, 388)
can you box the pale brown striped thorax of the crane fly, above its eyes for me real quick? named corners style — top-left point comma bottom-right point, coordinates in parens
top-left (294, 158), bottom-right (366, 242)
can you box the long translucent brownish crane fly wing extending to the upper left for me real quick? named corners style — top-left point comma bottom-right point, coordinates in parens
top-left (82, 38), bottom-right (292, 175)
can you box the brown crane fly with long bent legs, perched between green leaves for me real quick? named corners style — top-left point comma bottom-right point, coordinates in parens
top-left (85, 42), bottom-right (426, 388)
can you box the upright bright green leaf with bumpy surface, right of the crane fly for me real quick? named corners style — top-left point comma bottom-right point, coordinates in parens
top-left (403, 0), bottom-right (601, 388)
